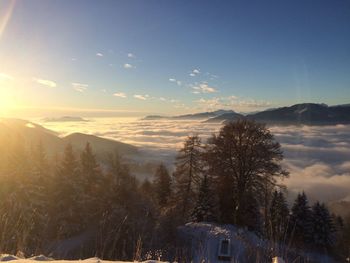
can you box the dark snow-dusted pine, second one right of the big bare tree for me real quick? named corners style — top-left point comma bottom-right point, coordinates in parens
top-left (289, 192), bottom-right (312, 246)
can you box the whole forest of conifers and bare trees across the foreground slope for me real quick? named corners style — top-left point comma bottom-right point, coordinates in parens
top-left (0, 120), bottom-right (350, 261)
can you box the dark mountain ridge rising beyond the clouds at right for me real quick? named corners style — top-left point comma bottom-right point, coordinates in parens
top-left (206, 103), bottom-right (350, 125)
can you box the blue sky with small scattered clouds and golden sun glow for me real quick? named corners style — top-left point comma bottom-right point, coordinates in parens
top-left (0, 0), bottom-right (350, 116)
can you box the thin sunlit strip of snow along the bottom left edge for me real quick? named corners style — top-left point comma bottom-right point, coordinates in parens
top-left (0, 254), bottom-right (166, 263)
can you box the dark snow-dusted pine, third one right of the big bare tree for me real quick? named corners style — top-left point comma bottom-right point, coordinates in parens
top-left (312, 202), bottom-right (336, 251)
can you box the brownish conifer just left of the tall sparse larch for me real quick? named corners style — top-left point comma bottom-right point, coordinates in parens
top-left (153, 164), bottom-right (171, 207)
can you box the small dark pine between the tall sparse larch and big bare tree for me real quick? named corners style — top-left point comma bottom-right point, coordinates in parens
top-left (192, 175), bottom-right (216, 222)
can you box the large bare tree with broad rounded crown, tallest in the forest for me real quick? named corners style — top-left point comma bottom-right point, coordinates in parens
top-left (206, 120), bottom-right (288, 225)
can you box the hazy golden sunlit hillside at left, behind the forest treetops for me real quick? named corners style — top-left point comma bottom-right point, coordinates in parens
top-left (0, 118), bottom-right (138, 157)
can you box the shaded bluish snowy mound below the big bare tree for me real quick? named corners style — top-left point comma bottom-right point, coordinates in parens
top-left (178, 222), bottom-right (335, 263)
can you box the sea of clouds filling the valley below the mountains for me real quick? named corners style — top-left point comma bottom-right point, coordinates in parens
top-left (41, 118), bottom-right (350, 206)
